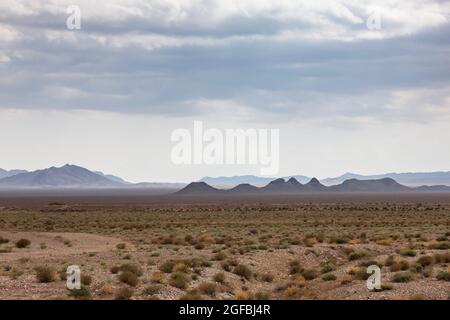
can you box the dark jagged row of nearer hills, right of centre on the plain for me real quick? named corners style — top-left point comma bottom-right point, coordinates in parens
top-left (175, 177), bottom-right (450, 195)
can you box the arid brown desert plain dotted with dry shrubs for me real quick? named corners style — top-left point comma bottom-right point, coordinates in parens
top-left (0, 193), bottom-right (450, 299)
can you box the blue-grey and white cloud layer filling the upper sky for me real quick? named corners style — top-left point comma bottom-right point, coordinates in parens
top-left (0, 0), bottom-right (450, 123)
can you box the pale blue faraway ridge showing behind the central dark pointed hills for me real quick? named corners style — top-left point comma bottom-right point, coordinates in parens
top-left (200, 175), bottom-right (311, 188)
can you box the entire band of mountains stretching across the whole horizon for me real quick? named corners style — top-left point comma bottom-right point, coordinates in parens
top-left (0, 164), bottom-right (450, 194)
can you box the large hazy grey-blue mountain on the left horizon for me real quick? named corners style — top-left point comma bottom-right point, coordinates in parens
top-left (0, 165), bottom-right (123, 188)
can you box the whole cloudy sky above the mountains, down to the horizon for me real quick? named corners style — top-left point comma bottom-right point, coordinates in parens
top-left (0, 0), bottom-right (450, 182)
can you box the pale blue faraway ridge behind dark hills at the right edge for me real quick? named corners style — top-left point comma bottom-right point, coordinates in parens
top-left (322, 171), bottom-right (450, 187)
